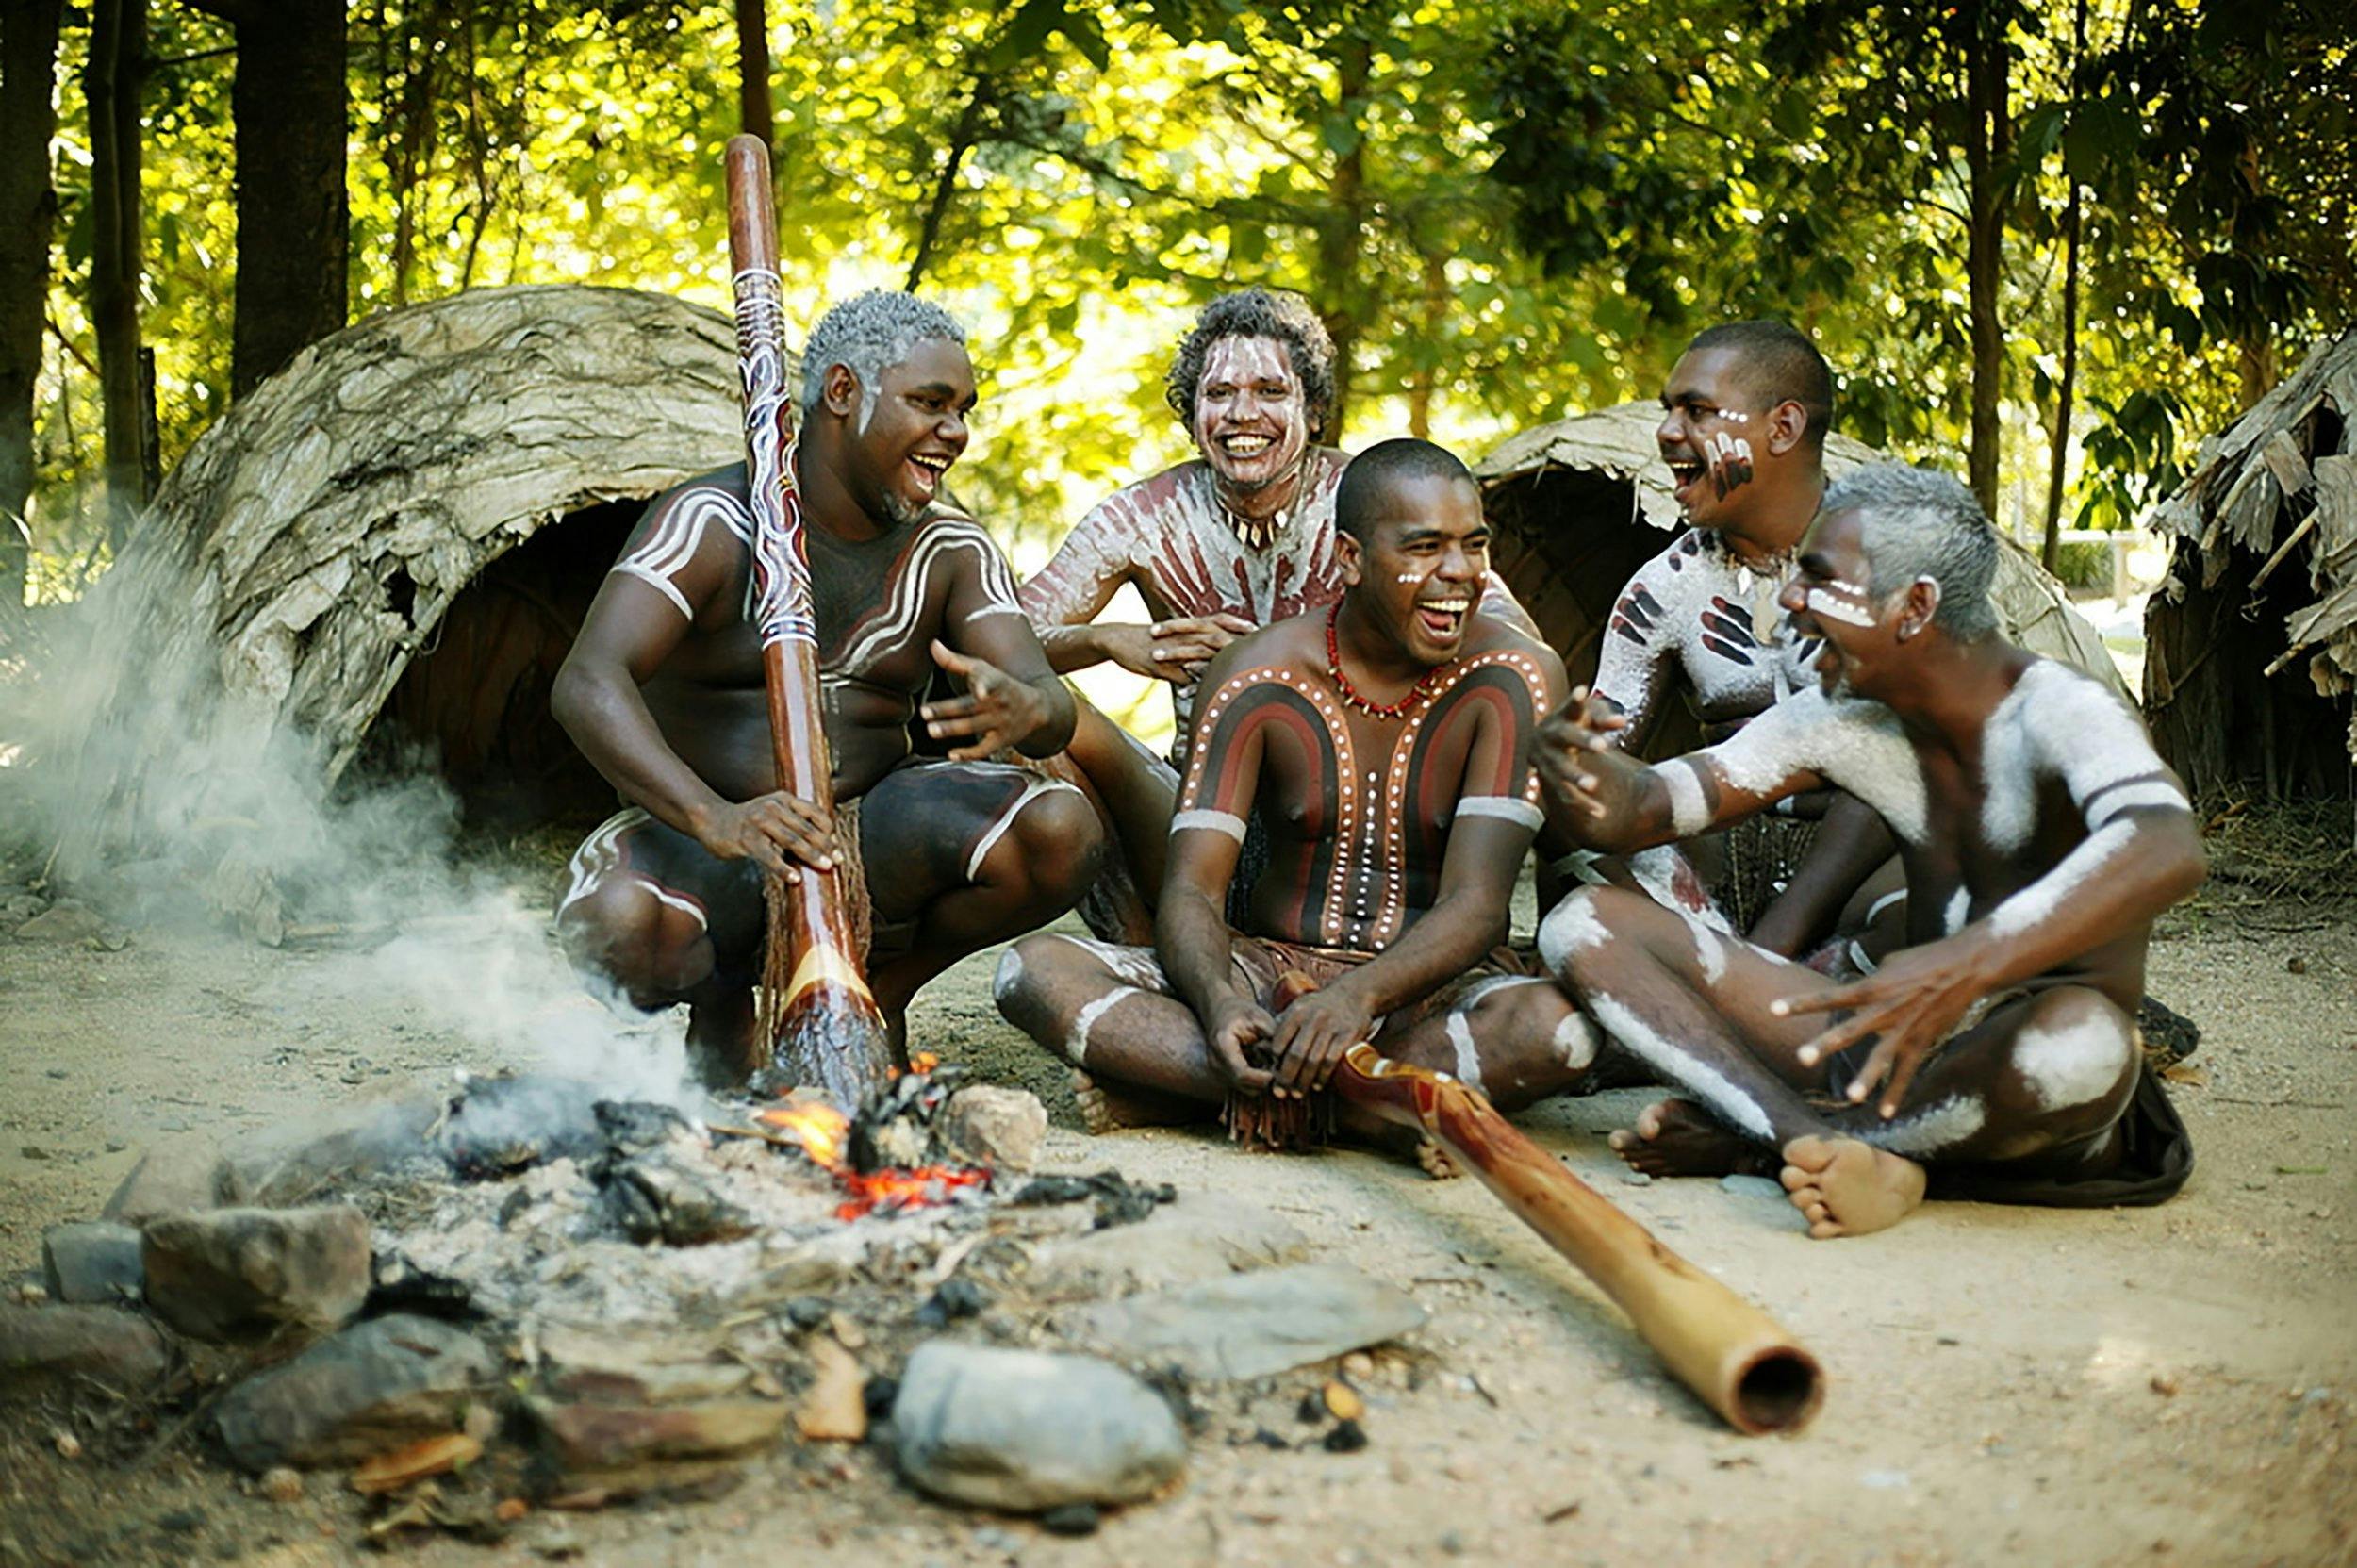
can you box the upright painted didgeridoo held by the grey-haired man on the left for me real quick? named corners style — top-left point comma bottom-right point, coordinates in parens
top-left (726, 137), bottom-right (891, 1111)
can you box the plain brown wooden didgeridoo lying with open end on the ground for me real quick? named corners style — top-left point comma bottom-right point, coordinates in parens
top-left (1332, 1042), bottom-right (1824, 1436)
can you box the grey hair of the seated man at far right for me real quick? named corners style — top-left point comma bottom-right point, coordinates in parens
top-left (1822, 462), bottom-right (2002, 641)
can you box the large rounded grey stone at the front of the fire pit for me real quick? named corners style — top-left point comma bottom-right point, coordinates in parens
top-left (891, 1339), bottom-right (1186, 1513)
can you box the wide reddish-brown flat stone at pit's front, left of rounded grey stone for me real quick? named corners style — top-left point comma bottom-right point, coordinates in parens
top-left (528, 1398), bottom-right (790, 1494)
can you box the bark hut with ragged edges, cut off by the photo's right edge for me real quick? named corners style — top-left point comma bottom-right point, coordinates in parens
top-left (2145, 333), bottom-right (2357, 795)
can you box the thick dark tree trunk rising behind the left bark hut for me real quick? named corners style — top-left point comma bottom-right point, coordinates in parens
top-left (226, 0), bottom-right (349, 396)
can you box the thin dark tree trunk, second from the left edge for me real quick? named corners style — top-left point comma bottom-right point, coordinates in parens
top-left (83, 0), bottom-right (149, 552)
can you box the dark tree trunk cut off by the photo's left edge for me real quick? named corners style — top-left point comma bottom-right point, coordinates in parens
top-left (0, 0), bottom-right (64, 618)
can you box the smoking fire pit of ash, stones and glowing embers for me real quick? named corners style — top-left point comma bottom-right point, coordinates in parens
top-left (0, 1059), bottom-right (1426, 1544)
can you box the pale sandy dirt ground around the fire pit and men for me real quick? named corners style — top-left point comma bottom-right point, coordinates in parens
top-left (0, 844), bottom-right (2357, 1568)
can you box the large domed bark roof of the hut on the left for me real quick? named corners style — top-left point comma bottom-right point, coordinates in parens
top-left (53, 286), bottom-right (743, 861)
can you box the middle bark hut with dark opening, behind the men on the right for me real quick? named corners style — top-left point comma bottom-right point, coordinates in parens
top-left (1474, 404), bottom-right (2134, 701)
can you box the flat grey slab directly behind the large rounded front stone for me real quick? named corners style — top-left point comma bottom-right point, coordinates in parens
top-left (1059, 1263), bottom-right (1426, 1381)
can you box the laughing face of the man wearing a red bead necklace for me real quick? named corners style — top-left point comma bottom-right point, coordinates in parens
top-left (1337, 474), bottom-right (1490, 669)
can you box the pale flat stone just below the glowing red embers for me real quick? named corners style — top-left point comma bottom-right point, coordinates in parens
top-left (1023, 1193), bottom-right (1310, 1301)
